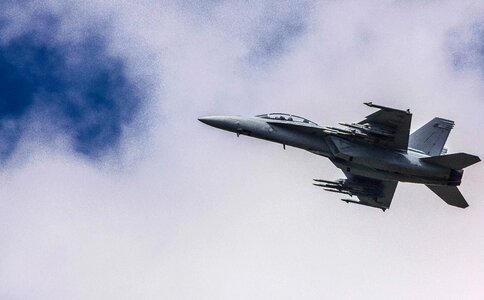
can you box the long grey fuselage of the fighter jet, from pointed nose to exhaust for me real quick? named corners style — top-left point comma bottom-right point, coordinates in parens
top-left (199, 116), bottom-right (463, 185)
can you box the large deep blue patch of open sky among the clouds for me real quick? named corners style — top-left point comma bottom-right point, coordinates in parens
top-left (0, 3), bottom-right (143, 162)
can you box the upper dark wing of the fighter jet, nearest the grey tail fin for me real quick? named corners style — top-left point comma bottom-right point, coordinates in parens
top-left (354, 102), bottom-right (412, 150)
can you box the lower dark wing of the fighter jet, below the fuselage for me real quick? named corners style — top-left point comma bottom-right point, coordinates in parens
top-left (343, 172), bottom-right (398, 211)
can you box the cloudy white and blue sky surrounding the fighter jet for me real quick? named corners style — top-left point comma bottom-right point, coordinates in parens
top-left (0, 0), bottom-right (484, 300)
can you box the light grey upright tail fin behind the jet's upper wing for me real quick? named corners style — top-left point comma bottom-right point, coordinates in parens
top-left (408, 118), bottom-right (454, 156)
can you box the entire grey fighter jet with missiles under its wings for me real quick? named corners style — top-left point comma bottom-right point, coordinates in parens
top-left (198, 102), bottom-right (480, 211)
